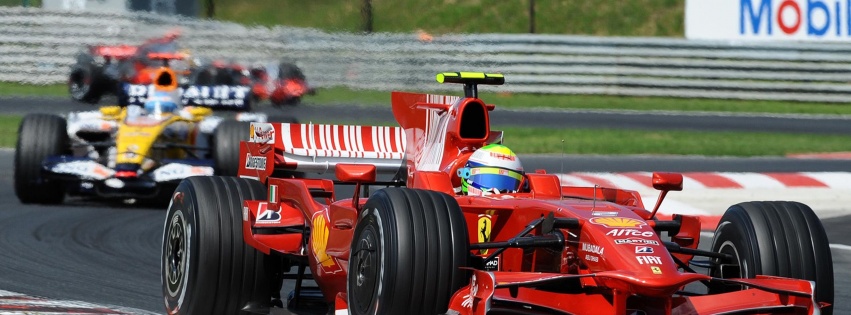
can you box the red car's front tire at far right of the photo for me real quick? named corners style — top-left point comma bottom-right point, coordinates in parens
top-left (710, 201), bottom-right (834, 314)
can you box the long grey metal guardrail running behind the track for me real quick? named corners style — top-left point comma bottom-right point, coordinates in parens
top-left (0, 7), bottom-right (851, 103)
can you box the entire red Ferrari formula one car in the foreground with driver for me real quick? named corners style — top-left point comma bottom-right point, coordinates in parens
top-left (161, 73), bottom-right (834, 315)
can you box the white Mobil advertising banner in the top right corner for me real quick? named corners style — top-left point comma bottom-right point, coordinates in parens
top-left (685, 0), bottom-right (851, 42)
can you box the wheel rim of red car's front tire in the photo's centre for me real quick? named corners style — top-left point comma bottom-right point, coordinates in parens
top-left (350, 227), bottom-right (380, 313)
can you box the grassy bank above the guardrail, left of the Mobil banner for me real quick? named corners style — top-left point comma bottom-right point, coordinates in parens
top-left (201, 0), bottom-right (685, 37)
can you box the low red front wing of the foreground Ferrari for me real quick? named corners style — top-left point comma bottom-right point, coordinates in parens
top-left (448, 270), bottom-right (821, 315)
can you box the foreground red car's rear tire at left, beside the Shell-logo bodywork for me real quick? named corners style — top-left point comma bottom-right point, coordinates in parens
top-left (161, 176), bottom-right (271, 315)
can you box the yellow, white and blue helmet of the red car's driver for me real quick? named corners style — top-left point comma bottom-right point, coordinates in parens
top-left (458, 144), bottom-right (523, 196)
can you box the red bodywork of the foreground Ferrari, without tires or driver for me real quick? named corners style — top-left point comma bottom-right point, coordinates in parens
top-left (239, 92), bottom-right (818, 315)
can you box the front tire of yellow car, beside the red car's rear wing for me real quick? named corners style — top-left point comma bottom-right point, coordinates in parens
top-left (212, 120), bottom-right (251, 176)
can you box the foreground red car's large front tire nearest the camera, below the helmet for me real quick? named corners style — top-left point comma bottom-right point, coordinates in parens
top-left (347, 187), bottom-right (469, 315)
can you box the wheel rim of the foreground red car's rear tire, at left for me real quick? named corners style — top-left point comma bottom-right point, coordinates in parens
top-left (163, 211), bottom-right (189, 297)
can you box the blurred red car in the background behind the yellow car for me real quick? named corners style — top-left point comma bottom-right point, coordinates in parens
top-left (68, 31), bottom-right (314, 105)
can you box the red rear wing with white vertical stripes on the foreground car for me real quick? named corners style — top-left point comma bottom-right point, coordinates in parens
top-left (239, 123), bottom-right (405, 181)
